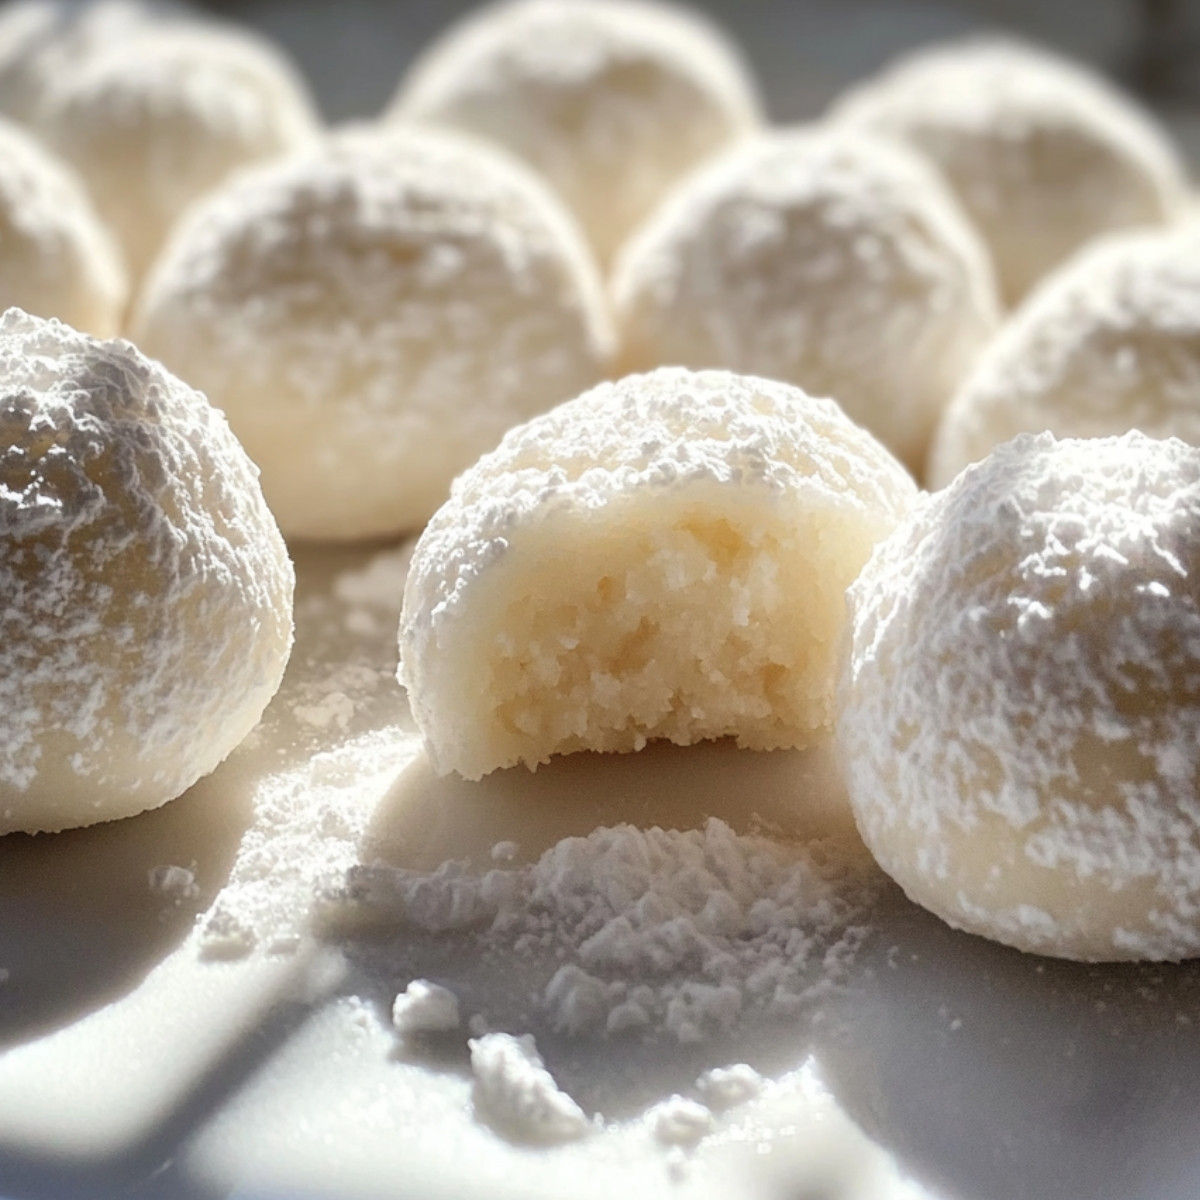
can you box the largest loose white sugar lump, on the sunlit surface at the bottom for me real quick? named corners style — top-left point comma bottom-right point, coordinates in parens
top-left (469, 1033), bottom-right (589, 1142)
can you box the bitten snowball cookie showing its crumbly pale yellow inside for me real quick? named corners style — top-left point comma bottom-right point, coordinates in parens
top-left (398, 368), bottom-right (916, 779)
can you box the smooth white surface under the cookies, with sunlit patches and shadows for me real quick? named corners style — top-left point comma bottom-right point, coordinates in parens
top-left (0, 540), bottom-right (1200, 1200)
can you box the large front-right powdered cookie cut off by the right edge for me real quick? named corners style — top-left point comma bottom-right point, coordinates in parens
top-left (836, 433), bottom-right (1200, 960)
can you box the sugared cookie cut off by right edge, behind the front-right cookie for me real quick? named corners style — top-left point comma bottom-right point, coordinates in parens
top-left (928, 224), bottom-right (1200, 487)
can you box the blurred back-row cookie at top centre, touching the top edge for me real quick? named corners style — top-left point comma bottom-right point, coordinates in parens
top-left (391, 0), bottom-right (761, 263)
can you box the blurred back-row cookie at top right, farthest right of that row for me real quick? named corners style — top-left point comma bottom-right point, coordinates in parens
top-left (833, 38), bottom-right (1187, 304)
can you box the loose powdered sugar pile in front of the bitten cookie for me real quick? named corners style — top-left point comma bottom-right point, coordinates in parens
top-left (320, 818), bottom-right (877, 1043)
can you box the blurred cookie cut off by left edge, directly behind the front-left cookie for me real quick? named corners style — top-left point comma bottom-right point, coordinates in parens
top-left (0, 120), bottom-right (128, 337)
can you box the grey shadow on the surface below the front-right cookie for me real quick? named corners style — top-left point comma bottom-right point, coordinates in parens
top-left (818, 888), bottom-right (1200, 1200)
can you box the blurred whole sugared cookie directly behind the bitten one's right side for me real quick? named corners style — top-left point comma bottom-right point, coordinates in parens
top-left (612, 130), bottom-right (1000, 468)
